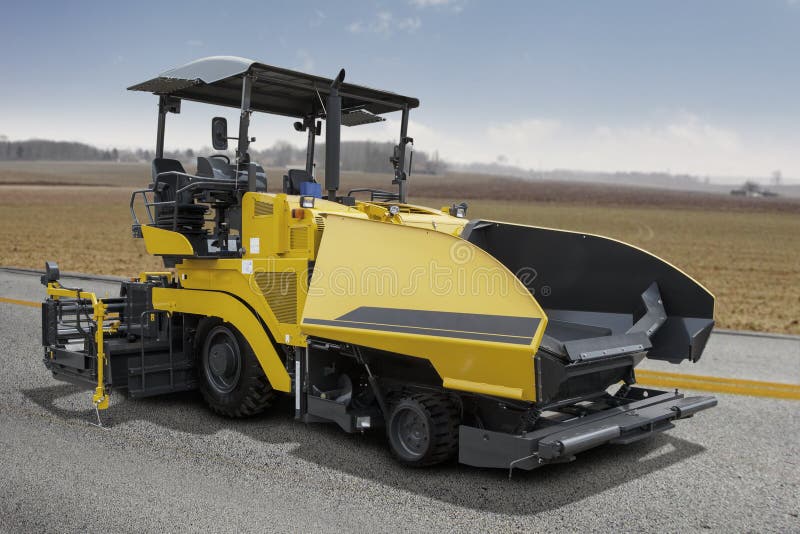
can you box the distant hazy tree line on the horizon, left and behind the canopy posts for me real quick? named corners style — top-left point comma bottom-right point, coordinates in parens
top-left (0, 137), bottom-right (446, 174)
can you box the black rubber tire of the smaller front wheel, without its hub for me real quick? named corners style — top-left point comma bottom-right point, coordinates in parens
top-left (386, 393), bottom-right (461, 467)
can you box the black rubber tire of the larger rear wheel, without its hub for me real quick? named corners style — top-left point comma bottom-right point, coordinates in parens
top-left (195, 318), bottom-right (276, 418)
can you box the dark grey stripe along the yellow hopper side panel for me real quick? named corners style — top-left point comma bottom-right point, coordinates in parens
top-left (337, 306), bottom-right (539, 338)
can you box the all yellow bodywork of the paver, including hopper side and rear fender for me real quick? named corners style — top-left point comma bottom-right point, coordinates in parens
top-left (143, 193), bottom-right (547, 400)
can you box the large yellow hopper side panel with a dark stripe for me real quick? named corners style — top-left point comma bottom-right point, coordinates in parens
top-left (301, 215), bottom-right (547, 400)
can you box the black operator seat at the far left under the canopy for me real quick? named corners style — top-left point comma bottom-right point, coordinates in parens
top-left (152, 158), bottom-right (206, 235)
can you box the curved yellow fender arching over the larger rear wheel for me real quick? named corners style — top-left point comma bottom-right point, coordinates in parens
top-left (153, 287), bottom-right (292, 392)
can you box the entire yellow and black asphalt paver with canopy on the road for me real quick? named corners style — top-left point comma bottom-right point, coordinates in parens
top-left (42, 57), bottom-right (716, 469)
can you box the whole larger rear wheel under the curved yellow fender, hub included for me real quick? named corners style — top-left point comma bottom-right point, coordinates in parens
top-left (197, 319), bottom-right (275, 417)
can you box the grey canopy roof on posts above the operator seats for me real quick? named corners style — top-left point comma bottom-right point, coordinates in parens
top-left (128, 56), bottom-right (419, 118)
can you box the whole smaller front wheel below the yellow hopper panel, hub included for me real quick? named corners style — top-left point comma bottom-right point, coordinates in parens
top-left (387, 393), bottom-right (460, 467)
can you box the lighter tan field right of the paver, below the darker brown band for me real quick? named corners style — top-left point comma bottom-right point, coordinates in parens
top-left (416, 200), bottom-right (800, 334)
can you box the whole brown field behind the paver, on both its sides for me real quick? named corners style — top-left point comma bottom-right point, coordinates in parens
top-left (0, 162), bottom-right (800, 334)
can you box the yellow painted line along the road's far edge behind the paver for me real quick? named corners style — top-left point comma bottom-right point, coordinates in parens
top-left (0, 297), bottom-right (800, 400)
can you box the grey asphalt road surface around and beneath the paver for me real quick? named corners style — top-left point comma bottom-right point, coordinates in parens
top-left (0, 270), bottom-right (800, 532)
